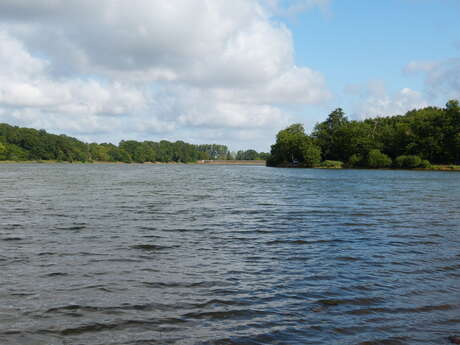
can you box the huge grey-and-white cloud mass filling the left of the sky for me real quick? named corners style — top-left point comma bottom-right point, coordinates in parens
top-left (0, 0), bottom-right (330, 148)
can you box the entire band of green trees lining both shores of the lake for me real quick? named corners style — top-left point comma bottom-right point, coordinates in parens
top-left (0, 100), bottom-right (460, 168)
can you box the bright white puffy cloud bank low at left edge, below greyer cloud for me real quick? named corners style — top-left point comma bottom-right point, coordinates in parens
top-left (0, 31), bottom-right (146, 125)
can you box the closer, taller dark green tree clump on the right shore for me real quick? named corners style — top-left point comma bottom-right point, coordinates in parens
top-left (267, 100), bottom-right (460, 169)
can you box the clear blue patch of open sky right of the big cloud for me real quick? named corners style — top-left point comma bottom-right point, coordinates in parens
top-left (281, 0), bottom-right (460, 126)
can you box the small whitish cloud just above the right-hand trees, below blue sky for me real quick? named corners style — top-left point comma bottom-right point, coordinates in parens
top-left (345, 81), bottom-right (428, 119)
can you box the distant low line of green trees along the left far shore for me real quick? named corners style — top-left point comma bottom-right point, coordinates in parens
top-left (0, 124), bottom-right (268, 163)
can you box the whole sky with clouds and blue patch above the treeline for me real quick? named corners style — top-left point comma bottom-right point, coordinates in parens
top-left (0, 0), bottom-right (460, 151)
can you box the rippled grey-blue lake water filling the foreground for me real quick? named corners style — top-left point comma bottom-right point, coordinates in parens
top-left (0, 165), bottom-right (460, 345)
